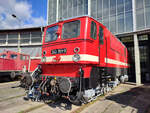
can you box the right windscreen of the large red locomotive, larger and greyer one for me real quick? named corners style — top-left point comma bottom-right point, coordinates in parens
top-left (62, 20), bottom-right (80, 39)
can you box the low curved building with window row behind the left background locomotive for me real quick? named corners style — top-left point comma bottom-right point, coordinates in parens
top-left (0, 27), bottom-right (42, 57)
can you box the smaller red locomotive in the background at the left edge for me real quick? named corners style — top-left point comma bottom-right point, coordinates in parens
top-left (0, 50), bottom-right (41, 79)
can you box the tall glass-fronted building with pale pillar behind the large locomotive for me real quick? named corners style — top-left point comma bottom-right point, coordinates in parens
top-left (47, 0), bottom-right (150, 84)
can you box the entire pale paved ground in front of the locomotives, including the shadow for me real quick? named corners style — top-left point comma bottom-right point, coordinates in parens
top-left (0, 81), bottom-right (150, 113)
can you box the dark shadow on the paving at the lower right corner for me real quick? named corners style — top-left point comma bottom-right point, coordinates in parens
top-left (106, 84), bottom-right (150, 113)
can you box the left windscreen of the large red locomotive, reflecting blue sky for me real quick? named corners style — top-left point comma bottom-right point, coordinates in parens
top-left (45, 26), bottom-right (58, 42)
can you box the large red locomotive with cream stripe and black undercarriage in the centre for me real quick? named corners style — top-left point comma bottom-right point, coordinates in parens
top-left (24, 16), bottom-right (129, 104)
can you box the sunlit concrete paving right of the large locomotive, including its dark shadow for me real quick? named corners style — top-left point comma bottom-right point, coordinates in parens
top-left (78, 84), bottom-right (150, 113)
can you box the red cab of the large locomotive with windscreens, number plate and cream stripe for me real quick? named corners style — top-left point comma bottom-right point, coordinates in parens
top-left (42, 17), bottom-right (99, 64)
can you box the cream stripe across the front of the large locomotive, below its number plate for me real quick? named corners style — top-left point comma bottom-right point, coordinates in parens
top-left (42, 54), bottom-right (99, 62)
